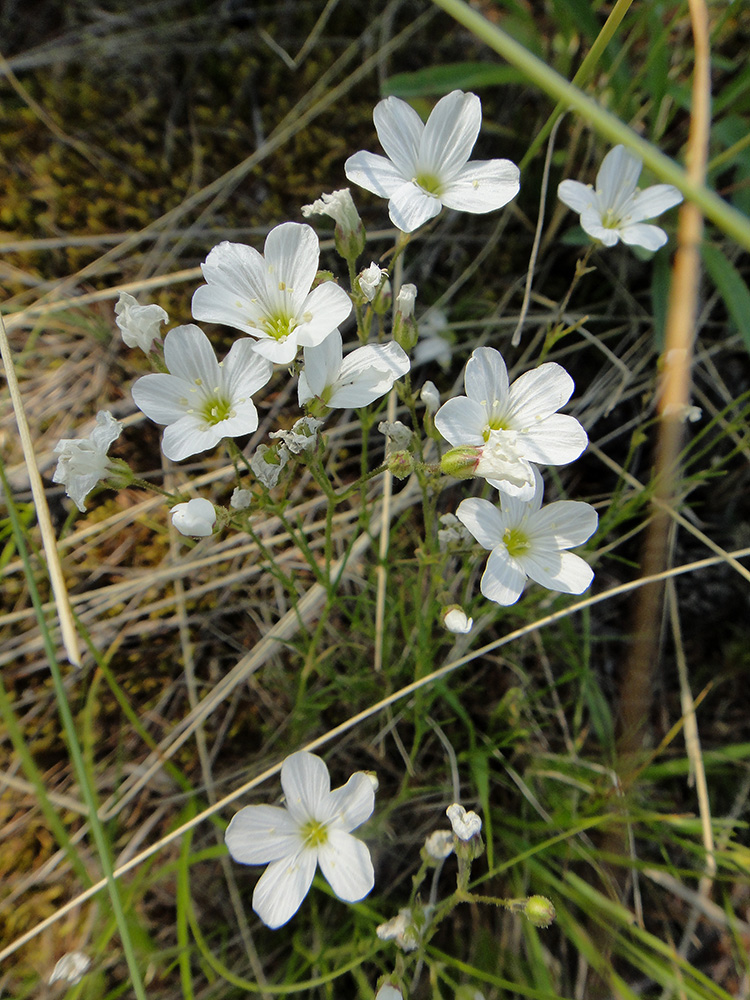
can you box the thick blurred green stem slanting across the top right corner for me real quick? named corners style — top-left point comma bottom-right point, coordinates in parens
top-left (433, 0), bottom-right (750, 250)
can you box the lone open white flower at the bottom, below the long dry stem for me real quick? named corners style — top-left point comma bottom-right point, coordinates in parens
top-left (225, 750), bottom-right (375, 927)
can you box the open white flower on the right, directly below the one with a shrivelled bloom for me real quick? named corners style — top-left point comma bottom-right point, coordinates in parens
top-left (456, 472), bottom-right (598, 605)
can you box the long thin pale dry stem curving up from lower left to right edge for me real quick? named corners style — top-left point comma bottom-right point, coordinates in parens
top-left (0, 544), bottom-right (750, 962)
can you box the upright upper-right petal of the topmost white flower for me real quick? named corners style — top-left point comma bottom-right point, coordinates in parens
top-left (420, 90), bottom-right (482, 182)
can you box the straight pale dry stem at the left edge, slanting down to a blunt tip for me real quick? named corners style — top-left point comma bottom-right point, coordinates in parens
top-left (0, 315), bottom-right (81, 667)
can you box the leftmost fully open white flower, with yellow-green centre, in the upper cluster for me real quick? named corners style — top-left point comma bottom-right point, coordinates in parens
top-left (132, 323), bottom-right (273, 462)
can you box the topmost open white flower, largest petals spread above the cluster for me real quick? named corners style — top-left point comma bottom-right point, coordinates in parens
top-left (344, 90), bottom-right (519, 233)
